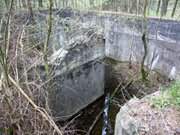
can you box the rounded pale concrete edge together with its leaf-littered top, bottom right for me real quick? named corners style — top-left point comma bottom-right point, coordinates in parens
top-left (116, 91), bottom-right (180, 135)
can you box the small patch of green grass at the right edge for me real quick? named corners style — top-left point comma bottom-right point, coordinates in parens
top-left (152, 81), bottom-right (180, 108)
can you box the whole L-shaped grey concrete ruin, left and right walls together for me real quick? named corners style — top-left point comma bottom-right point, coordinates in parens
top-left (35, 10), bottom-right (180, 118)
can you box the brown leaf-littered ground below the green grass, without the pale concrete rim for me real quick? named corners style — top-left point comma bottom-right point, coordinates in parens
top-left (125, 91), bottom-right (180, 135)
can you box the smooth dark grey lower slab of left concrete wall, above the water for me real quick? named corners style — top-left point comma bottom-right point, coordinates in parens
top-left (49, 61), bottom-right (104, 119)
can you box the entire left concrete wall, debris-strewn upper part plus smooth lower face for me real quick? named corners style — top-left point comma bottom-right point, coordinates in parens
top-left (45, 21), bottom-right (105, 119)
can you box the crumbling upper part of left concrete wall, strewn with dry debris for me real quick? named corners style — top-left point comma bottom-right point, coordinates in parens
top-left (49, 17), bottom-right (105, 74)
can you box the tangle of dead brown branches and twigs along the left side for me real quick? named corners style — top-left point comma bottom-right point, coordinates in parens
top-left (0, 7), bottom-right (63, 135)
